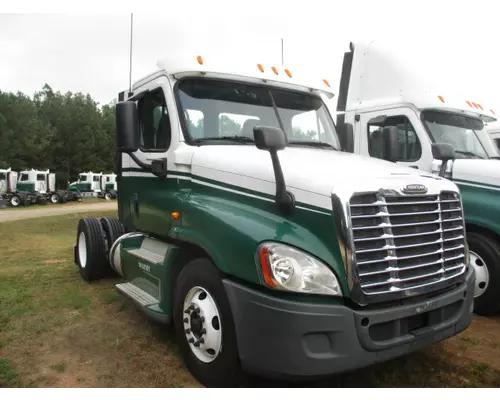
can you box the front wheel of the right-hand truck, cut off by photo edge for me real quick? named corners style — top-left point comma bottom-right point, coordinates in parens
top-left (467, 232), bottom-right (500, 316)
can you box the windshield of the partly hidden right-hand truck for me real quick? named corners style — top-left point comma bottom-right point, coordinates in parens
top-left (422, 111), bottom-right (500, 159)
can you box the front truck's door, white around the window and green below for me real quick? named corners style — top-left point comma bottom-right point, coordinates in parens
top-left (120, 77), bottom-right (183, 236)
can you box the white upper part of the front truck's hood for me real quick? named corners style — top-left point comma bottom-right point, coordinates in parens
top-left (188, 145), bottom-right (457, 209)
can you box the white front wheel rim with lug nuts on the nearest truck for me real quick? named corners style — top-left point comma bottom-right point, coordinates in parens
top-left (183, 286), bottom-right (222, 363)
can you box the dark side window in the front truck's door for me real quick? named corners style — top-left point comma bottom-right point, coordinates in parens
top-left (138, 88), bottom-right (172, 152)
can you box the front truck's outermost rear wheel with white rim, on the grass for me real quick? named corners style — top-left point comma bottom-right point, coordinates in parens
top-left (76, 218), bottom-right (109, 282)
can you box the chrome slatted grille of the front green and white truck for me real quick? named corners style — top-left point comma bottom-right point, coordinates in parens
top-left (349, 192), bottom-right (466, 295)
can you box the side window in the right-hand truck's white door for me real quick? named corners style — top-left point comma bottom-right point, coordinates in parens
top-left (368, 115), bottom-right (422, 162)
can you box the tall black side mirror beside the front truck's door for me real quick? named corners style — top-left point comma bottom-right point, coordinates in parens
top-left (116, 101), bottom-right (139, 153)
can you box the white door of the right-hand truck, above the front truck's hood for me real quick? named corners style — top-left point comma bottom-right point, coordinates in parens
top-left (356, 108), bottom-right (433, 172)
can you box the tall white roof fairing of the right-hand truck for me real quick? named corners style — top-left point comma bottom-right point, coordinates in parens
top-left (346, 40), bottom-right (497, 122)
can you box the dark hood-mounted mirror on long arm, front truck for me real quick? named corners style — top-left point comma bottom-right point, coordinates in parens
top-left (253, 126), bottom-right (295, 214)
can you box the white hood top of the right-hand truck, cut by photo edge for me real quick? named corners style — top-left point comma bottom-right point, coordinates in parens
top-left (448, 159), bottom-right (500, 189)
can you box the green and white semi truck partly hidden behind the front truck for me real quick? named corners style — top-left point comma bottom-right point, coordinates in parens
top-left (337, 41), bottom-right (500, 315)
